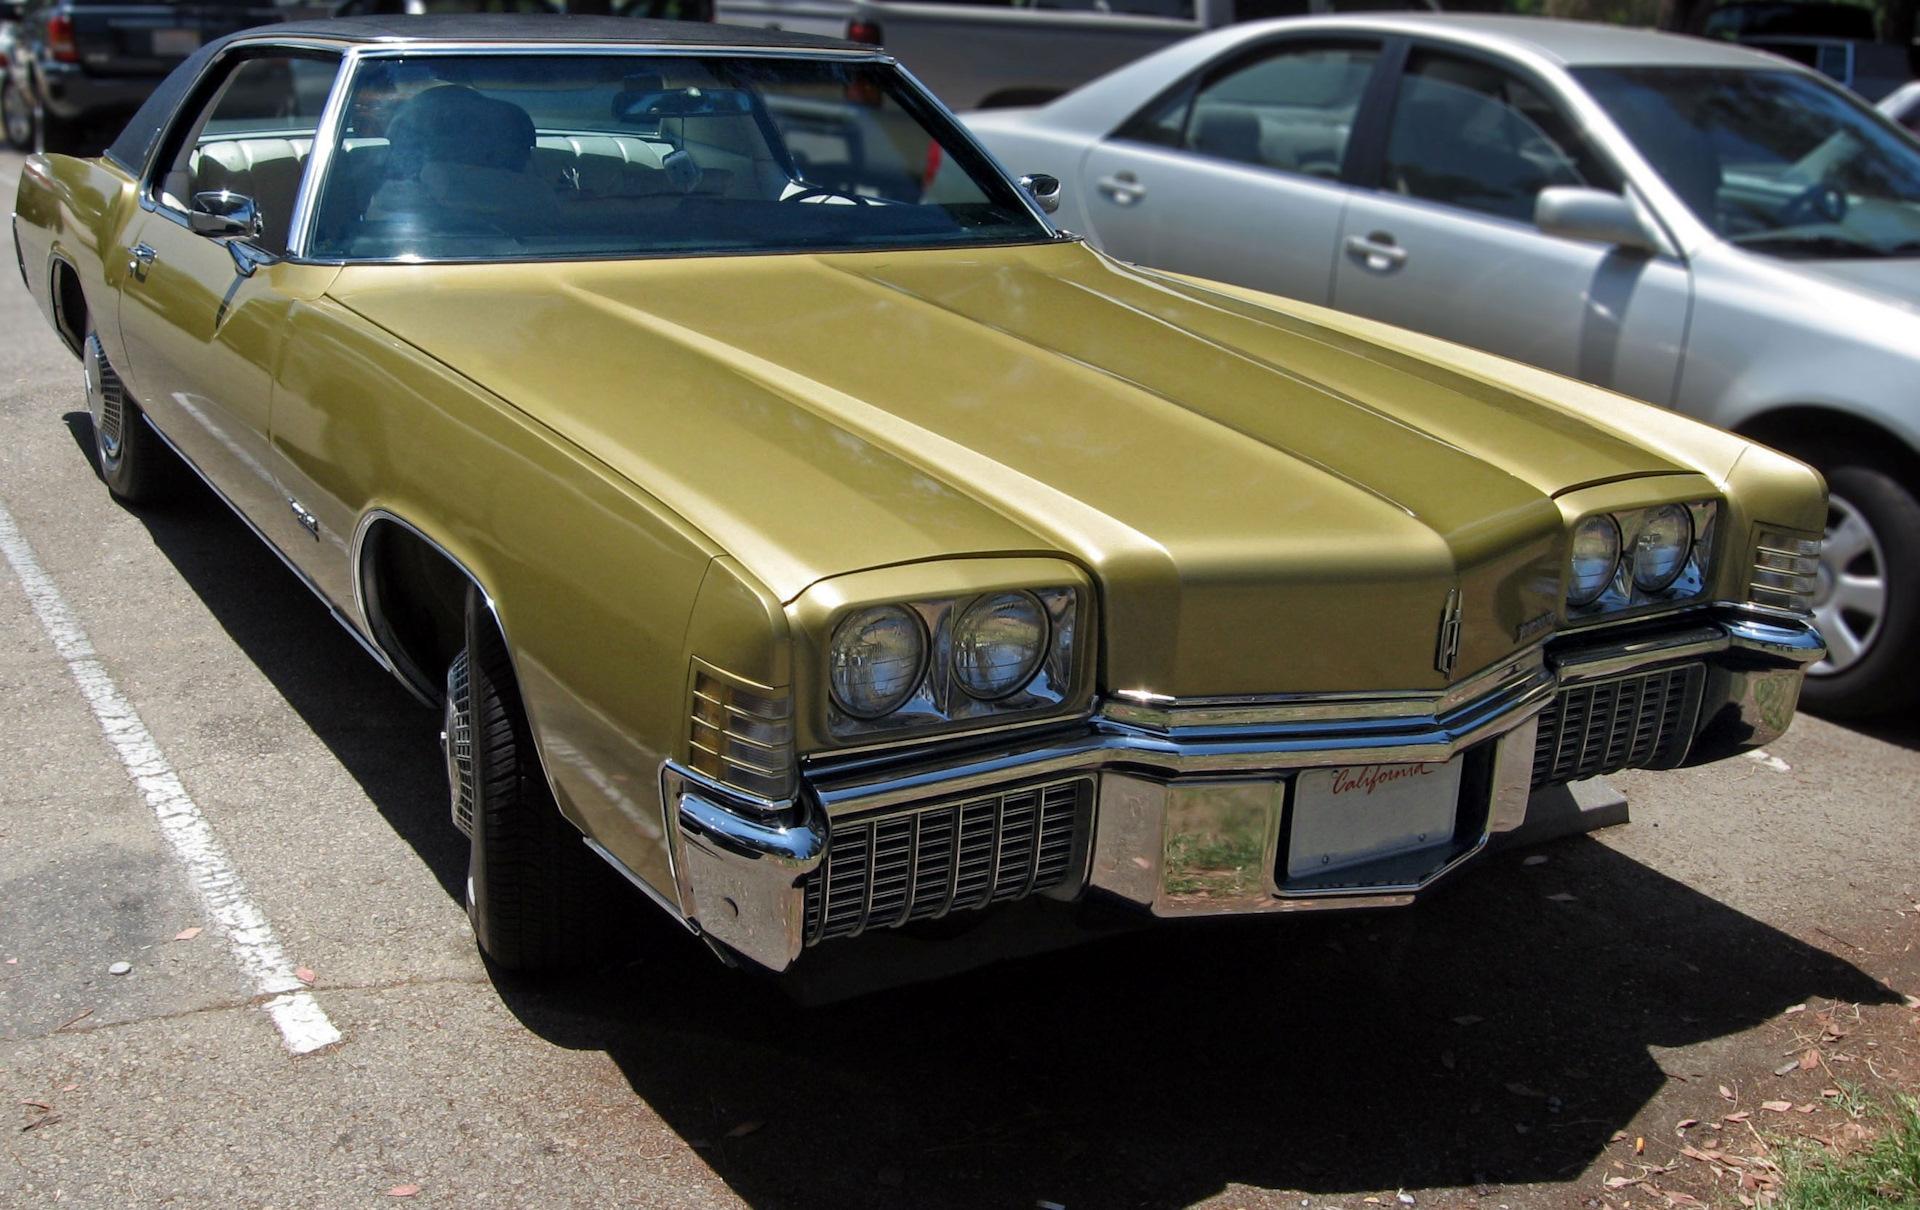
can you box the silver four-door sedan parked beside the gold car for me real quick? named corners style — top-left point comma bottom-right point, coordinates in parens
top-left (968, 13), bottom-right (1920, 714)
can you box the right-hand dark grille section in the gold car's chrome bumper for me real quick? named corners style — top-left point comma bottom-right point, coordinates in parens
top-left (1534, 665), bottom-right (1707, 786)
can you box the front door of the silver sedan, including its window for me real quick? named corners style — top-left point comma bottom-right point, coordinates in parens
top-left (1332, 46), bottom-right (1692, 403)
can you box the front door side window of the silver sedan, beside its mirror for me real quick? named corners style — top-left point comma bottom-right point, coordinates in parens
top-left (1384, 52), bottom-right (1620, 223)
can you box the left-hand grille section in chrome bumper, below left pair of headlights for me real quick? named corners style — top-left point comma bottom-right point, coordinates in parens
top-left (806, 778), bottom-right (1092, 945)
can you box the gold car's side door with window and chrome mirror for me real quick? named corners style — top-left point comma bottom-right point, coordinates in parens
top-left (119, 52), bottom-right (340, 538)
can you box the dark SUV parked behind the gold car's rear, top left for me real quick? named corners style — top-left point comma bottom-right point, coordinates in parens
top-left (0, 0), bottom-right (280, 152)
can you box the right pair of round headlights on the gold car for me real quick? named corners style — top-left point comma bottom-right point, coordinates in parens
top-left (1567, 501), bottom-right (1715, 615)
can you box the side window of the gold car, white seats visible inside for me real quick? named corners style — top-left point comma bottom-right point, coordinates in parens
top-left (156, 56), bottom-right (340, 254)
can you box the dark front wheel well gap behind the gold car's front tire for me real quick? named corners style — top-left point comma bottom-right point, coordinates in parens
top-left (359, 520), bottom-right (472, 701)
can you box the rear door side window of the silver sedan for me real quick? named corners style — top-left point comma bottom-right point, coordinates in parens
top-left (1119, 44), bottom-right (1379, 179)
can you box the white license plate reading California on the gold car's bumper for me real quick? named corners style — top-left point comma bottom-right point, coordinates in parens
top-left (1286, 757), bottom-right (1459, 878)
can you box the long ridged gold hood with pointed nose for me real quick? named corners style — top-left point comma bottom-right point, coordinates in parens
top-left (330, 244), bottom-right (1692, 695)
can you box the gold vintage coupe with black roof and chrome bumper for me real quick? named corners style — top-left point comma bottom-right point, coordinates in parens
top-left (13, 17), bottom-right (1824, 970)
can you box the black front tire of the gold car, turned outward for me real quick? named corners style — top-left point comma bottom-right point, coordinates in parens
top-left (447, 588), bottom-right (626, 976)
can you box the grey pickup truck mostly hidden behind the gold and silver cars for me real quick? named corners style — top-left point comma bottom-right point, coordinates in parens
top-left (718, 0), bottom-right (1440, 109)
